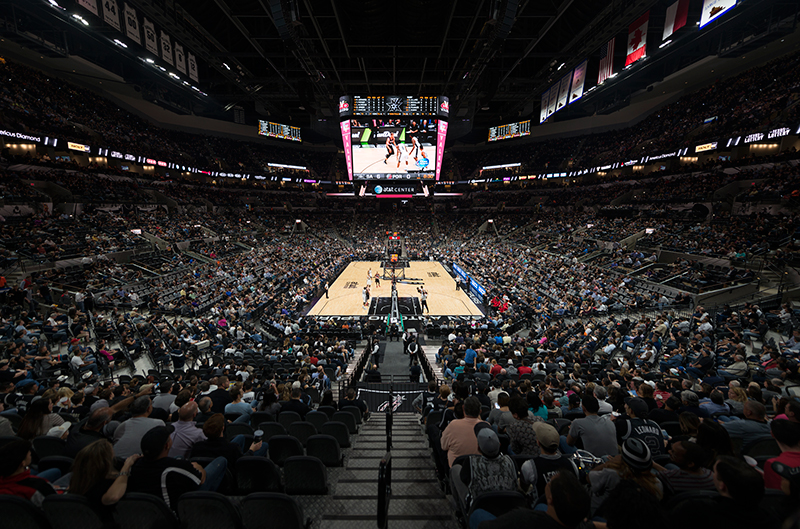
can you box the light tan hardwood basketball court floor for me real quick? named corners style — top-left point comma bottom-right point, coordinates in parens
top-left (308, 261), bottom-right (483, 316)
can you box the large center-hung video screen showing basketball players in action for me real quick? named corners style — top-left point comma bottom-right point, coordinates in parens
top-left (343, 116), bottom-right (438, 180)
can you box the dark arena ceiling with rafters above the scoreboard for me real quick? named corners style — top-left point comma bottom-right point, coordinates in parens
top-left (0, 0), bottom-right (798, 140)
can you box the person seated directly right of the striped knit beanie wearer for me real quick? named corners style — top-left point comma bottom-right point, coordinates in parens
top-left (653, 441), bottom-right (714, 494)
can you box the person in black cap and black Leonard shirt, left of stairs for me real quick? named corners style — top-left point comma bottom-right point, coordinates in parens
top-left (128, 426), bottom-right (228, 509)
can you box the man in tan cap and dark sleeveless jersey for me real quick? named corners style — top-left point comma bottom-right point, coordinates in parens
top-left (519, 422), bottom-right (580, 505)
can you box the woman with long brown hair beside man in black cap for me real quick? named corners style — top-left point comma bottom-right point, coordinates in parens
top-left (69, 439), bottom-right (141, 527)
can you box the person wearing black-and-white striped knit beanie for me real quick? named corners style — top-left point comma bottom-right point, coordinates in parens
top-left (586, 437), bottom-right (664, 513)
